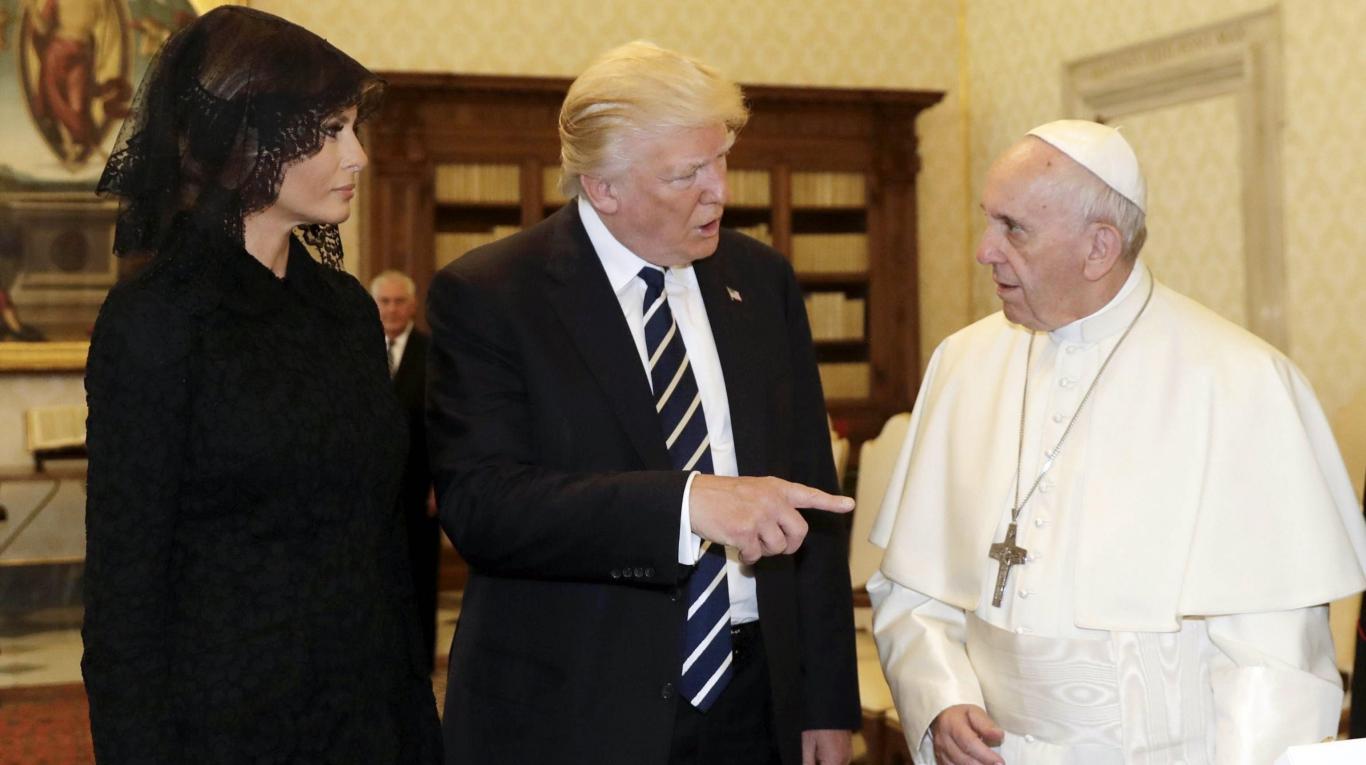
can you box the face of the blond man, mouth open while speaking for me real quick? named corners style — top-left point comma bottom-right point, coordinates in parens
top-left (602, 124), bottom-right (735, 268)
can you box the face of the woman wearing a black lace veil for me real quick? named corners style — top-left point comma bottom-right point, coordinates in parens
top-left (272, 107), bottom-right (367, 225)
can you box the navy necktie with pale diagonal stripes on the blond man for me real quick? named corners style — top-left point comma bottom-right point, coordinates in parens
top-left (641, 266), bottom-right (731, 712)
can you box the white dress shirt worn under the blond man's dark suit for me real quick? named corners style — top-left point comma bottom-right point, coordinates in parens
top-left (578, 197), bottom-right (759, 624)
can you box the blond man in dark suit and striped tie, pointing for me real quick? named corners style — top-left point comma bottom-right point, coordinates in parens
top-left (428, 42), bottom-right (859, 765)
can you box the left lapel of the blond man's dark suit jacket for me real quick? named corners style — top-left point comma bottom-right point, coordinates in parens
top-left (546, 202), bottom-right (672, 470)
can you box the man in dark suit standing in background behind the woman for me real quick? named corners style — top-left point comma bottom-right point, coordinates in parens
top-left (370, 270), bottom-right (441, 672)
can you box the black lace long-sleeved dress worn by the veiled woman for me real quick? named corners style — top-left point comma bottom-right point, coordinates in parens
top-left (82, 227), bottom-right (440, 765)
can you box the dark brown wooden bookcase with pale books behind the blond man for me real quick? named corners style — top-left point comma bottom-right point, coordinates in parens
top-left (361, 72), bottom-right (943, 459)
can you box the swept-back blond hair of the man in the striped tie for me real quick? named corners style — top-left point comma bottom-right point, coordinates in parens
top-left (560, 40), bottom-right (750, 197)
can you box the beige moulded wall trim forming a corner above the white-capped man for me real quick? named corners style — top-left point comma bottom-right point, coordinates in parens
top-left (1063, 7), bottom-right (1288, 351)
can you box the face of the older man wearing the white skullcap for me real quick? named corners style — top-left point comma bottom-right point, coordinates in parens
top-left (977, 138), bottom-right (1091, 331)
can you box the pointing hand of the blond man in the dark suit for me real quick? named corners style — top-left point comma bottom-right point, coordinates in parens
top-left (688, 474), bottom-right (854, 563)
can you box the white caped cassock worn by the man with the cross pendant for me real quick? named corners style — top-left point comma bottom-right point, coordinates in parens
top-left (867, 262), bottom-right (1366, 765)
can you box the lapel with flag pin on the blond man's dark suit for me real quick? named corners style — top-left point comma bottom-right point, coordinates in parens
top-left (693, 240), bottom-right (768, 475)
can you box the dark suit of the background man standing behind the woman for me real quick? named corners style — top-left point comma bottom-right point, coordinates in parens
top-left (393, 326), bottom-right (441, 669)
